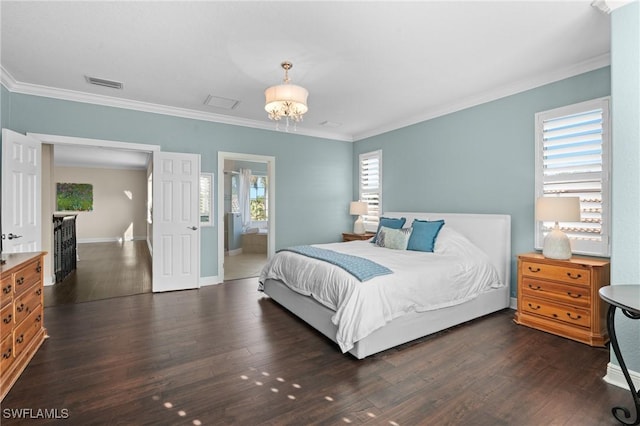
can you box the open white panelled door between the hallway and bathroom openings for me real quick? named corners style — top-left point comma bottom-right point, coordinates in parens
top-left (152, 151), bottom-right (200, 292)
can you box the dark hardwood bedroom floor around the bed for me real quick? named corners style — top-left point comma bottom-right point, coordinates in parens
top-left (2, 279), bottom-right (631, 425)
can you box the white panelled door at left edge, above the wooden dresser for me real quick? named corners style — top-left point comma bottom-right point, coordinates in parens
top-left (0, 129), bottom-right (42, 253)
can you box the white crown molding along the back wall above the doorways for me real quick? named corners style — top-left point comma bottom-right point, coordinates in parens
top-left (0, 65), bottom-right (353, 142)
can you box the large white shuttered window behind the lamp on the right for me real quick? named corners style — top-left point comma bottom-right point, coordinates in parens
top-left (535, 98), bottom-right (611, 256)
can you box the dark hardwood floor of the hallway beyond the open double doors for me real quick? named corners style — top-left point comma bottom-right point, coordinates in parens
top-left (44, 240), bottom-right (151, 307)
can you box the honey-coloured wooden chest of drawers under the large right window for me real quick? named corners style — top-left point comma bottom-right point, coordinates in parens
top-left (514, 253), bottom-right (609, 346)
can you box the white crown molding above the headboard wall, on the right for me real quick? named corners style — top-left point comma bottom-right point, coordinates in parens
top-left (353, 53), bottom-right (611, 141)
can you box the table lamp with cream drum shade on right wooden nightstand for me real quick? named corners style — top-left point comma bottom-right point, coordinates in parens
top-left (536, 197), bottom-right (580, 260)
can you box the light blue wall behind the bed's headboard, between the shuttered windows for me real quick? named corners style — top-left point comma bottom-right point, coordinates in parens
top-left (353, 67), bottom-right (611, 296)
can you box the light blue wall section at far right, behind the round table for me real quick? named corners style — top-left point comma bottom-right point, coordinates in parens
top-left (611, 2), bottom-right (640, 373)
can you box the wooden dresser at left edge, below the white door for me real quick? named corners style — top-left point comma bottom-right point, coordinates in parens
top-left (0, 252), bottom-right (46, 400)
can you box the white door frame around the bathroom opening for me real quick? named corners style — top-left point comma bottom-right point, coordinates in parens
top-left (216, 151), bottom-right (276, 283)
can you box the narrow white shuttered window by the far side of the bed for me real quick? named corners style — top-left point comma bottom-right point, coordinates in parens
top-left (359, 150), bottom-right (382, 231)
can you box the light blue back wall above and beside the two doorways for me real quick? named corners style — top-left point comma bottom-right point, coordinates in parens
top-left (2, 88), bottom-right (353, 277)
